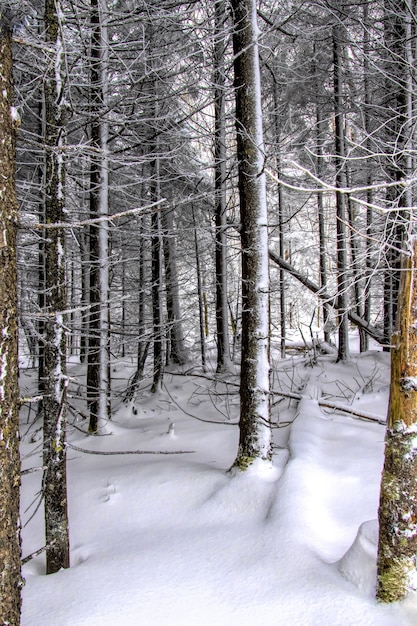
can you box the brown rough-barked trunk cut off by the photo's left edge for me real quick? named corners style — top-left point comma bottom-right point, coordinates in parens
top-left (0, 5), bottom-right (22, 626)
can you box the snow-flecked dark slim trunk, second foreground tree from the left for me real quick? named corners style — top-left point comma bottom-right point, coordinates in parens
top-left (42, 0), bottom-right (69, 574)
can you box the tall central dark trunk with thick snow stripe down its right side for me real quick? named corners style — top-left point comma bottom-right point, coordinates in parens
top-left (232, 0), bottom-right (271, 469)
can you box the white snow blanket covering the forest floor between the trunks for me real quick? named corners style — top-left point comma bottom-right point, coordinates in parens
top-left (21, 344), bottom-right (417, 626)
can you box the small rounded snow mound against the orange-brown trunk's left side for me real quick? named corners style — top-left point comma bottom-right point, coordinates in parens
top-left (336, 520), bottom-right (378, 596)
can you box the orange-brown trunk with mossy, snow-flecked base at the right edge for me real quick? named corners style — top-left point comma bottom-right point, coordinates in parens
top-left (377, 239), bottom-right (417, 602)
